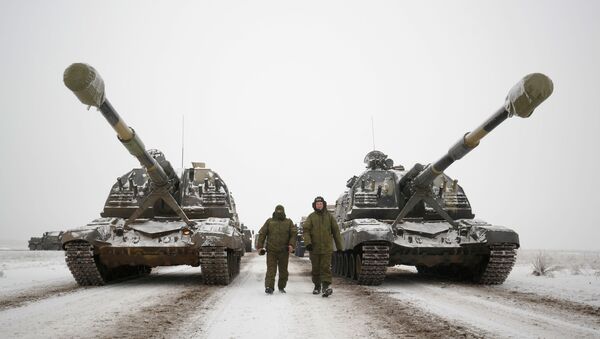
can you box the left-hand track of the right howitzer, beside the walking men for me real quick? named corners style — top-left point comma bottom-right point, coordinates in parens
top-left (356, 245), bottom-right (390, 286)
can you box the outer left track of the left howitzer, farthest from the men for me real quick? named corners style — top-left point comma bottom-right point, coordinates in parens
top-left (65, 241), bottom-right (106, 286)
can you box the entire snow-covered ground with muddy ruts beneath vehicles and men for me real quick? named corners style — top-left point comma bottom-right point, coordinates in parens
top-left (0, 251), bottom-right (600, 339)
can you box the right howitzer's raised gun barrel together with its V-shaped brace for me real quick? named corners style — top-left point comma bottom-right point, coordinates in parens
top-left (394, 73), bottom-right (554, 225)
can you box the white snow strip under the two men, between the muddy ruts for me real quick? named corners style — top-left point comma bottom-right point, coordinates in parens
top-left (175, 255), bottom-right (393, 339)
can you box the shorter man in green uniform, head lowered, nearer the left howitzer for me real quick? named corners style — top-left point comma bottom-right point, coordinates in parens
top-left (256, 205), bottom-right (297, 294)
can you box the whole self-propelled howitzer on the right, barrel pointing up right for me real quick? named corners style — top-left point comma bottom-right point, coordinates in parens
top-left (332, 73), bottom-right (553, 285)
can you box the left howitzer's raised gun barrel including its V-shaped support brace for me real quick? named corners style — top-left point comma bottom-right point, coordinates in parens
top-left (63, 63), bottom-right (194, 226)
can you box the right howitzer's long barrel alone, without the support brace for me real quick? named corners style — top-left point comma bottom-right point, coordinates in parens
top-left (414, 73), bottom-right (554, 186)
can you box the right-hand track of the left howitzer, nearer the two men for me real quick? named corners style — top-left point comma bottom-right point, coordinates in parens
top-left (199, 246), bottom-right (241, 285)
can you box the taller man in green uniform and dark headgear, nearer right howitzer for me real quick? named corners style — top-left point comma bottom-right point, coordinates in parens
top-left (302, 197), bottom-right (343, 297)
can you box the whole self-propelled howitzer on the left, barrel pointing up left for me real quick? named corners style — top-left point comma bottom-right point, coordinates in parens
top-left (62, 63), bottom-right (244, 285)
